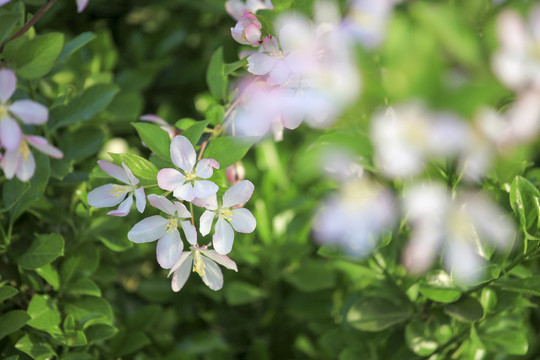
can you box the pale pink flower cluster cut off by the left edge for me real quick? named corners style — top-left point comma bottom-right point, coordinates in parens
top-left (0, 69), bottom-right (63, 181)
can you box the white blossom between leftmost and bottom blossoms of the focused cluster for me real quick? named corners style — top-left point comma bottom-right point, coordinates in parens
top-left (128, 194), bottom-right (197, 269)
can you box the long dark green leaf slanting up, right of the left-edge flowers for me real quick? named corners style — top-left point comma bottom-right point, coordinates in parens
top-left (49, 84), bottom-right (119, 129)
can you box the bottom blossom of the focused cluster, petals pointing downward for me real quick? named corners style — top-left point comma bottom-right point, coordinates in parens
top-left (169, 245), bottom-right (238, 291)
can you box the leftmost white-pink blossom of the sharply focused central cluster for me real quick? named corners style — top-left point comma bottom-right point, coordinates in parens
top-left (88, 160), bottom-right (146, 216)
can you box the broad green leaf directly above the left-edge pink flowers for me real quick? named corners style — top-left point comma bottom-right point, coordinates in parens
top-left (4, 33), bottom-right (64, 79)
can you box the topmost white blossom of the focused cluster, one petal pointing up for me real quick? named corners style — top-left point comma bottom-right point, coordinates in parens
top-left (157, 135), bottom-right (219, 201)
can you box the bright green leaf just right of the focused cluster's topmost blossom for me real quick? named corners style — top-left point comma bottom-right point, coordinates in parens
top-left (203, 136), bottom-right (258, 169)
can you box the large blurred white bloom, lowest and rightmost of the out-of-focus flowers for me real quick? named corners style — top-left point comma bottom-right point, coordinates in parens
top-left (403, 183), bottom-right (515, 284)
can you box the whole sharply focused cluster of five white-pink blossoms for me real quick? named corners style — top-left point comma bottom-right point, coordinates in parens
top-left (88, 135), bottom-right (256, 291)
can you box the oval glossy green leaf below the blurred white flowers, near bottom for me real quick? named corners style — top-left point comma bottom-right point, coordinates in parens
top-left (345, 297), bottom-right (412, 332)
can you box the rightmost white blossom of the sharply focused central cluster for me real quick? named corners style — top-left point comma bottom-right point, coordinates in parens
top-left (193, 180), bottom-right (257, 255)
